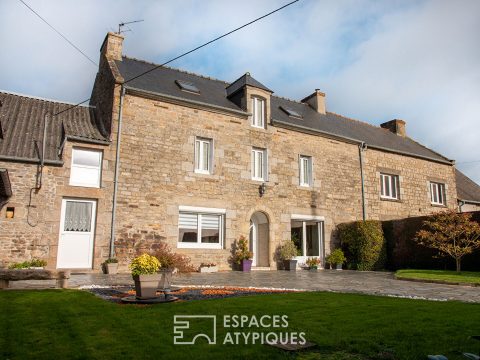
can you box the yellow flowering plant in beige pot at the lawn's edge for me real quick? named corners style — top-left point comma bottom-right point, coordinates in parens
top-left (130, 254), bottom-right (161, 299)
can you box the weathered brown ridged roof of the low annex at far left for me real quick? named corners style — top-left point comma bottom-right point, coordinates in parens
top-left (0, 91), bottom-right (109, 162)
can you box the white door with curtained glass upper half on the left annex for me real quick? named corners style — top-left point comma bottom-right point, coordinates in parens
top-left (57, 199), bottom-right (97, 269)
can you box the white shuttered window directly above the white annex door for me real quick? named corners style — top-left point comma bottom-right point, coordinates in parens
top-left (70, 148), bottom-right (102, 188)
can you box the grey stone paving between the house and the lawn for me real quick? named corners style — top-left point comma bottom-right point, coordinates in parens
top-left (6, 270), bottom-right (480, 303)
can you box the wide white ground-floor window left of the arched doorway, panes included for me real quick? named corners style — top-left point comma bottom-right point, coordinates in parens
top-left (178, 208), bottom-right (225, 249)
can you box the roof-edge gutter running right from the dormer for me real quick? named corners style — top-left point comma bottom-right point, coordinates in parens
top-left (272, 119), bottom-right (455, 165)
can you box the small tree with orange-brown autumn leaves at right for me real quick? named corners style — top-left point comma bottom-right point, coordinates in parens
top-left (415, 210), bottom-right (480, 272)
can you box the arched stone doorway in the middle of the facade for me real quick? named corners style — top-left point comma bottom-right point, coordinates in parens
top-left (250, 211), bottom-right (270, 267)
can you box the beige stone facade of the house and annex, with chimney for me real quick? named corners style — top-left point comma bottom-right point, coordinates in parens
top-left (0, 34), bottom-right (457, 271)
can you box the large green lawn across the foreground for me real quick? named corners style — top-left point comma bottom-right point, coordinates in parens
top-left (0, 290), bottom-right (480, 360)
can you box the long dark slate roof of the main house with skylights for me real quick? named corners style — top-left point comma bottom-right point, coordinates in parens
top-left (116, 57), bottom-right (450, 162)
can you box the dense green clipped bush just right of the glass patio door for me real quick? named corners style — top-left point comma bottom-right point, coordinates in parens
top-left (338, 220), bottom-right (387, 271)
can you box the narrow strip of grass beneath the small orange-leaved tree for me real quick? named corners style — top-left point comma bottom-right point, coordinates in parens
top-left (395, 269), bottom-right (480, 285)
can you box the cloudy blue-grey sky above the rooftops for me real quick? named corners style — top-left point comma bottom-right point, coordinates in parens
top-left (0, 0), bottom-right (480, 183)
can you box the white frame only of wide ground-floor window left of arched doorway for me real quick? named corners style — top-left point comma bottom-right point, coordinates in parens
top-left (177, 206), bottom-right (227, 249)
